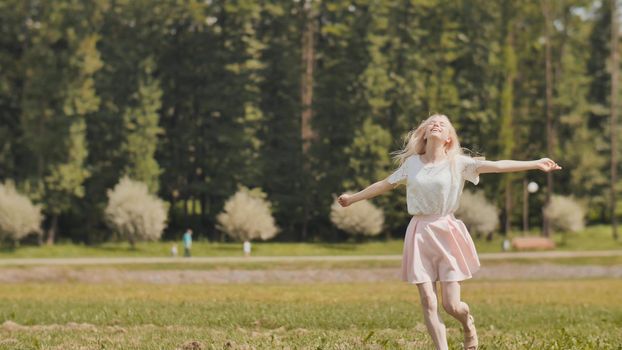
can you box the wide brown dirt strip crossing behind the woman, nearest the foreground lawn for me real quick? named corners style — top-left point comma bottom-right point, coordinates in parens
top-left (0, 264), bottom-right (622, 284)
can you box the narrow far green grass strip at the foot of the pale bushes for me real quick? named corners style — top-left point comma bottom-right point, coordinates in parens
top-left (0, 225), bottom-right (622, 258)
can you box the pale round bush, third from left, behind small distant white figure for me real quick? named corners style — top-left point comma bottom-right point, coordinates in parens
top-left (216, 187), bottom-right (279, 255)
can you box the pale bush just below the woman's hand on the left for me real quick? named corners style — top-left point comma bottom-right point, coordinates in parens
top-left (330, 196), bottom-right (384, 236)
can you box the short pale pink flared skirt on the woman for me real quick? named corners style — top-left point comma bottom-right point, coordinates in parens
top-left (402, 214), bottom-right (480, 284)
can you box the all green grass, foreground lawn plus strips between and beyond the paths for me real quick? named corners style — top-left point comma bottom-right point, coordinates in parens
top-left (0, 226), bottom-right (622, 350)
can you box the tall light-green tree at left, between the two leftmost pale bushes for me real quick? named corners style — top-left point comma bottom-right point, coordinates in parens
top-left (21, 2), bottom-right (104, 243)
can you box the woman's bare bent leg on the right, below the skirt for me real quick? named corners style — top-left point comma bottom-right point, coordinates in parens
top-left (441, 282), bottom-right (477, 350)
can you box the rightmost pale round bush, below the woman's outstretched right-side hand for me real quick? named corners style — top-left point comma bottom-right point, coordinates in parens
top-left (544, 195), bottom-right (585, 232)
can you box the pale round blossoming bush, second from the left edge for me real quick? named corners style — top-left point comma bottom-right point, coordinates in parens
top-left (105, 177), bottom-right (167, 246)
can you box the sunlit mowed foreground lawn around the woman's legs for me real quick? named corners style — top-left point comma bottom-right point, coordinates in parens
top-left (0, 279), bottom-right (622, 350)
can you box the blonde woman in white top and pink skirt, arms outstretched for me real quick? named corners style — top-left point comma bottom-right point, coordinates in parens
top-left (338, 114), bottom-right (561, 350)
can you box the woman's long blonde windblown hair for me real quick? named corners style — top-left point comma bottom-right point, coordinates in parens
top-left (392, 114), bottom-right (463, 173)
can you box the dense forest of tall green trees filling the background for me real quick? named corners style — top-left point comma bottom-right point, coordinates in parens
top-left (0, 0), bottom-right (622, 243)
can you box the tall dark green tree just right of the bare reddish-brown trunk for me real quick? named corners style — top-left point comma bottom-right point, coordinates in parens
top-left (309, 1), bottom-right (372, 238)
